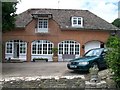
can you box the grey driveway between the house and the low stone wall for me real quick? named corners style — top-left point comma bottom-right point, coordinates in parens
top-left (2, 62), bottom-right (84, 78)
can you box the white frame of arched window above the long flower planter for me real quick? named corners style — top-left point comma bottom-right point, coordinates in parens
top-left (31, 40), bottom-right (54, 55)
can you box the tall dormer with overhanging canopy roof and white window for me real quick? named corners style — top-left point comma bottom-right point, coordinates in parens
top-left (32, 14), bottom-right (52, 33)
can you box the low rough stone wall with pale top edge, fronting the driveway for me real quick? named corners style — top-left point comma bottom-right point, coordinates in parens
top-left (2, 77), bottom-right (85, 88)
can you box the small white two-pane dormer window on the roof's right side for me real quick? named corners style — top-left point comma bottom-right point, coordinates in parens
top-left (71, 17), bottom-right (83, 27)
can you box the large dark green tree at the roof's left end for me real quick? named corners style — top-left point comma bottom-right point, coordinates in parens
top-left (2, 2), bottom-right (18, 32)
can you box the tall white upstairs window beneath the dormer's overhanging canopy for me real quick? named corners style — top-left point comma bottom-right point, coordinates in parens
top-left (36, 18), bottom-right (48, 33)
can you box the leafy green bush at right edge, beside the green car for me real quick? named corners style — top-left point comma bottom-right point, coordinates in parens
top-left (106, 36), bottom-right (120, 87)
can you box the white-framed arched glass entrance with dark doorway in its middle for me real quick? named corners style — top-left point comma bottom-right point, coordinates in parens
top-left (5, 40), bottom-right (27, 61)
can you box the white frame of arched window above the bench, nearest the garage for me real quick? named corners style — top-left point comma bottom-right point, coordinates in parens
top-left (58, 40), bottom-right (80, 55)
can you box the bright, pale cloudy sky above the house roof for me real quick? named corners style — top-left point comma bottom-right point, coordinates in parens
top-left (17, 0), bottom-right (120, 23)
